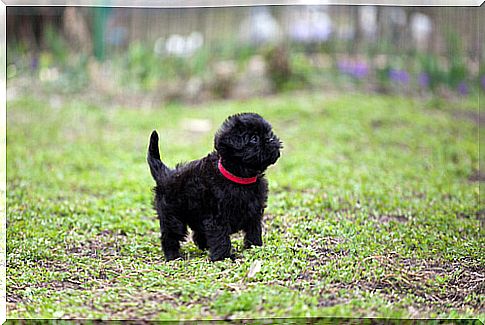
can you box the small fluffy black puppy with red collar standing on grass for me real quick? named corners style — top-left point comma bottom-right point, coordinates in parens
top-left (147, 113), bottom-right (281, 261)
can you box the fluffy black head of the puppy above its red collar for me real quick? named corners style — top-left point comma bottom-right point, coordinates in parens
top-left (214, 113), bottom-right (282, 176)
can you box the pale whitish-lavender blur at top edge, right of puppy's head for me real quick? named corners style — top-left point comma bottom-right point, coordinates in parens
top-left (289, 7), bottom-right (333, 43)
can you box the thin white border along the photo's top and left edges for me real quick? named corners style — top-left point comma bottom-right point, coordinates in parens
top-left (0, 0), bottom-right (485, 324)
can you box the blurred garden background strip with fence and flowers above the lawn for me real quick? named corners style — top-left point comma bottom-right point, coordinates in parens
top-left (7, 5), bottom-right (485, 107)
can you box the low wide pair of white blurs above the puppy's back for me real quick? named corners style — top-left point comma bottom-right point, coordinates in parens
top-left (164, 32), bottom-right (204, 56)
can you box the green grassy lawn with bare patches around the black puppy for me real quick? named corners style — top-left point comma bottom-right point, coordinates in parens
top-left (7, 90), bottom-right (485, 319)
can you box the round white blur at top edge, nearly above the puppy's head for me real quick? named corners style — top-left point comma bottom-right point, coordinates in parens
top-left (241, 7), bottom-right (281, 44)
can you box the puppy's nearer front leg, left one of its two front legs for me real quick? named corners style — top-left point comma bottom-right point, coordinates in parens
top-left (204, 220), bottom-right (234, 262)
